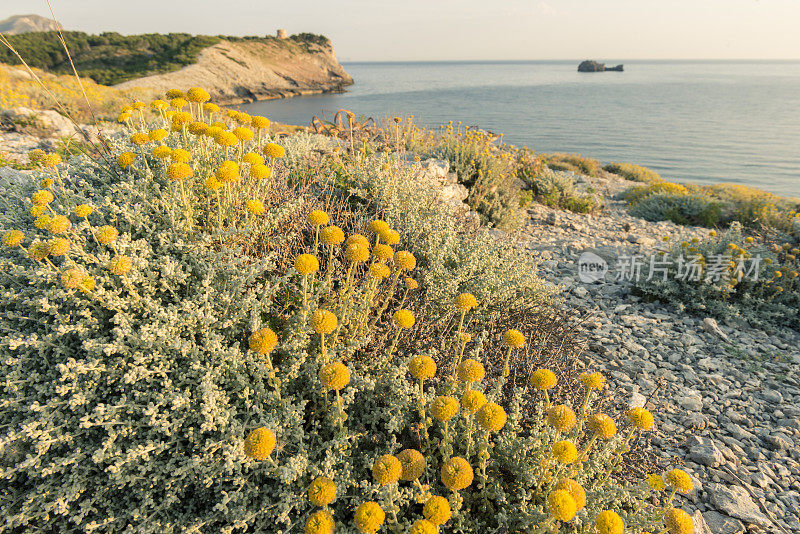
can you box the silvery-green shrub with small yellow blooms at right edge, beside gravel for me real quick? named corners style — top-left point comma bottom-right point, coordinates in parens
top-left (637, 223), bottom-right (800, 328)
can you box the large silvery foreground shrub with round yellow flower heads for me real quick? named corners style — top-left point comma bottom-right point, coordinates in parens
top-left (0, 90), bottom-right (691, 534)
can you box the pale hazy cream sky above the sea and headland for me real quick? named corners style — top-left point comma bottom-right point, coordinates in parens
top-left (0, 0), bottom-right (800, 61)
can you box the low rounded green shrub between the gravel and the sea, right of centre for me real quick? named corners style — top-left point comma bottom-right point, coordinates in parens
top-left (628, 193), bottom-right (722, 226)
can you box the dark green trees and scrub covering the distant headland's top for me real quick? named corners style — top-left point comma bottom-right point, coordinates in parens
top-left (0, 32), bottom-right (329, 85)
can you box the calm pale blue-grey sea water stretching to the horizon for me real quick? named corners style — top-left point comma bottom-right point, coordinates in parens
top-left (243, 61), bottom-right (800, 196)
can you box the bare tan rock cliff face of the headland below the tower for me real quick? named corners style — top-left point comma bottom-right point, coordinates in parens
top-left (115, 39), bottom-right (353, 104)
